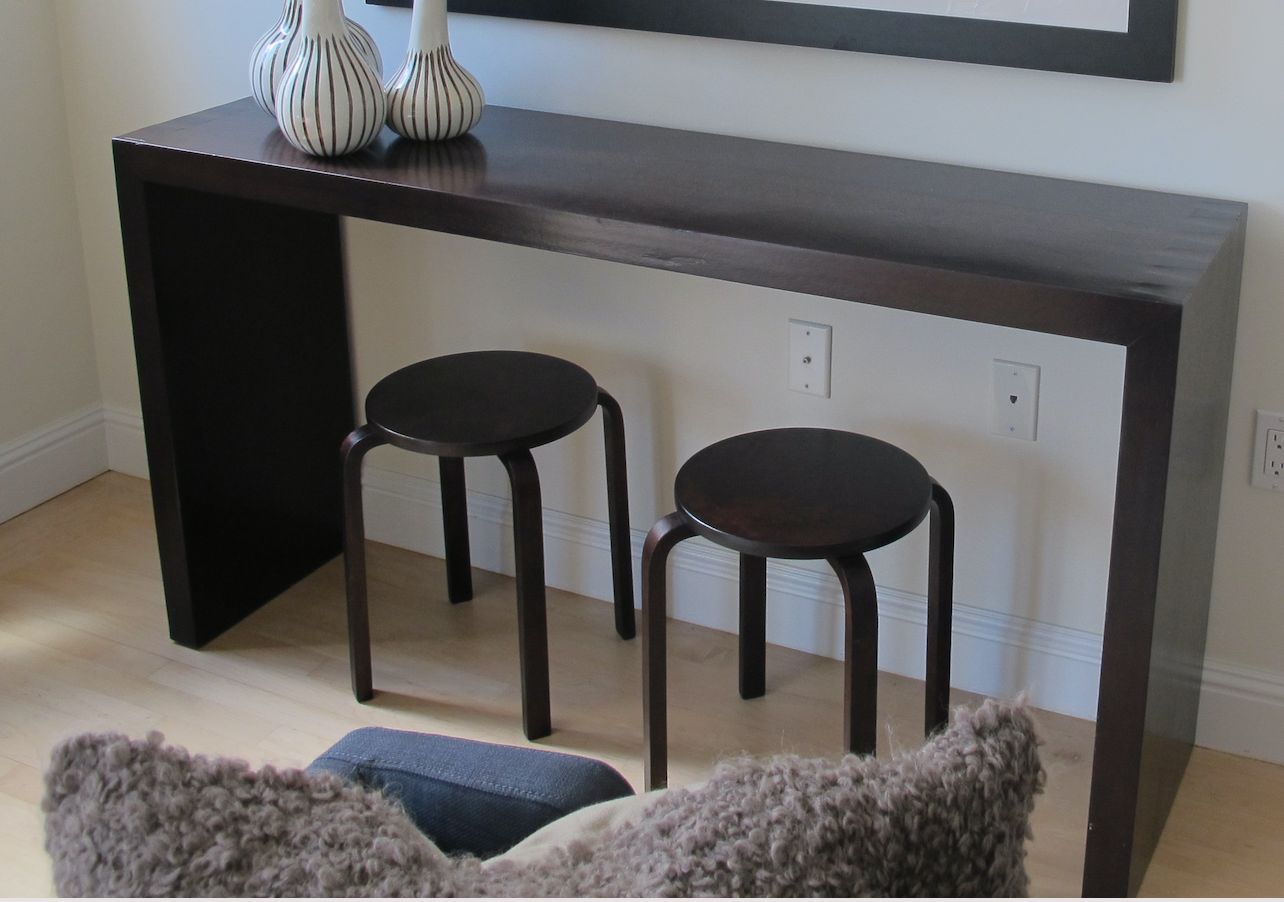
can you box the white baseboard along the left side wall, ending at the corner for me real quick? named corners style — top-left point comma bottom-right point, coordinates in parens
top-left (0, 405), bottom-right (108, 523)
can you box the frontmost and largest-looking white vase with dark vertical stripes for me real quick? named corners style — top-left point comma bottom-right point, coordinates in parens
top-left (276, 0), bottom-right (388, 157)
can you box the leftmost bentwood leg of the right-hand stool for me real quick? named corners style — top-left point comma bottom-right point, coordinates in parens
top-left (642, 513), bottom-right (696, 791)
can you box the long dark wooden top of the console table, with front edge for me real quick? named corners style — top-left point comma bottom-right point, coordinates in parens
top-left (116, 99), bottom-right (1245, 340)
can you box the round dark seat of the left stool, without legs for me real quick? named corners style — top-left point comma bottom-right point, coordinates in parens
top-left (366, 351), bottom-right (597, 457)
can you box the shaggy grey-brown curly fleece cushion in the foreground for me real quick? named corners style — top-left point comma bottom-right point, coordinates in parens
top-left (44, 702), bottom-right (1044, 896)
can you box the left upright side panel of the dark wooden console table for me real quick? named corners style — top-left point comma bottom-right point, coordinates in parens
top-left (118, 179), bottom-right (354, 648)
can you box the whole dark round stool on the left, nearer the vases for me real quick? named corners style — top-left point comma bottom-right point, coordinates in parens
top-left (343, 351), bottom-right (634, 739)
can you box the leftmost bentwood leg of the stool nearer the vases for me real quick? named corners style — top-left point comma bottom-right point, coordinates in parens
top-left (339, 425), bottom-right (384, 702)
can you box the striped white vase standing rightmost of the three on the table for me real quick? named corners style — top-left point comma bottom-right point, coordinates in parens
top-left (386, 0), bottom-right (485, 141)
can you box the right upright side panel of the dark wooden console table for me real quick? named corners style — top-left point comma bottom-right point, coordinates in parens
top-left (1084, 217), bottom-right (1245, 896)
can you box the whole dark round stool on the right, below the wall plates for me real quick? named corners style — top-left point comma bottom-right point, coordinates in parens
top-left (642, 429), bottom-right (954, 789)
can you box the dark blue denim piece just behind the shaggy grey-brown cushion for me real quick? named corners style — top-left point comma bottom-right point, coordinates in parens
top-left (308, 727), bottom-right (633, 858)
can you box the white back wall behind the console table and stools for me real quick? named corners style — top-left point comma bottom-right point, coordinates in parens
top-left (25, 0), bottom-right (1284, 761)
